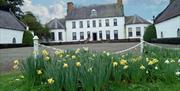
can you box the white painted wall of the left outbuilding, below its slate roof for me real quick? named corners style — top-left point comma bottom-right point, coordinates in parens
top-left (0, 28), bottom-right (24, 44)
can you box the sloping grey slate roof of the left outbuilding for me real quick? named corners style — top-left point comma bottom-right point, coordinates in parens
top-left (0, 10), bottom-right (26, 31)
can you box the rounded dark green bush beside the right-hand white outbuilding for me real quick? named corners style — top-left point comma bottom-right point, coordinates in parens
top-left (143, 24), bottom-right (157, 42)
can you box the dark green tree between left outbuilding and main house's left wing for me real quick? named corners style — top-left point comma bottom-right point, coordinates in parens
top-left (21, 12), bottom-right (50, 40)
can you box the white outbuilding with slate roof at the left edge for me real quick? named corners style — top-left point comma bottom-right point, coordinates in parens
top-left (0, 10), bottom-right (26, 44)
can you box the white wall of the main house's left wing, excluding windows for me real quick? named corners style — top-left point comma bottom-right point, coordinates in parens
top-left (50, 29), bottom-right (66, 42)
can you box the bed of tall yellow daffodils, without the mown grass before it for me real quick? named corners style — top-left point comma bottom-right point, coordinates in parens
top-left (13, 46), bottom-right (180, 91)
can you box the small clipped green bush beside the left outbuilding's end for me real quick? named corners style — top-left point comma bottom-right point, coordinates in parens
top-left (23, 31), bottom-right (33, 45)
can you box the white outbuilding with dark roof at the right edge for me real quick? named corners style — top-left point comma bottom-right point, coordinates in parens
top-left (155, 0), bottom-right (180, 38)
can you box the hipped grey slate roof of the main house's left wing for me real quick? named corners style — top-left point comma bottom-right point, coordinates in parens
top-left (46, 18), bottom-right (65, 29)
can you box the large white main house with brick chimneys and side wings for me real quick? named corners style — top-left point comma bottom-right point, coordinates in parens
top-left (47, 0), bottom-right (150, 42)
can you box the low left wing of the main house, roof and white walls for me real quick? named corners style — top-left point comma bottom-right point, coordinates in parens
top-left (47, 18), bottom-right (66, 42)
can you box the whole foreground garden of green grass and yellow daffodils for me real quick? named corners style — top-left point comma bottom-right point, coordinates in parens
top-left (0, 45), bottom-right (180, 91)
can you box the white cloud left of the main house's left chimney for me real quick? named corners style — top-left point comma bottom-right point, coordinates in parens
top-left (22, 0), bottom-right (65, 24)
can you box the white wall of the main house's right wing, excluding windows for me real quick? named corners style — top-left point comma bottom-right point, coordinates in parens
top-left (126, 24), bottom-right (150, 38)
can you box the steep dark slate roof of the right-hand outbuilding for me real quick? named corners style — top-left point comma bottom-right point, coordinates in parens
top-left (155, 0), bottom-right (180, 24)
